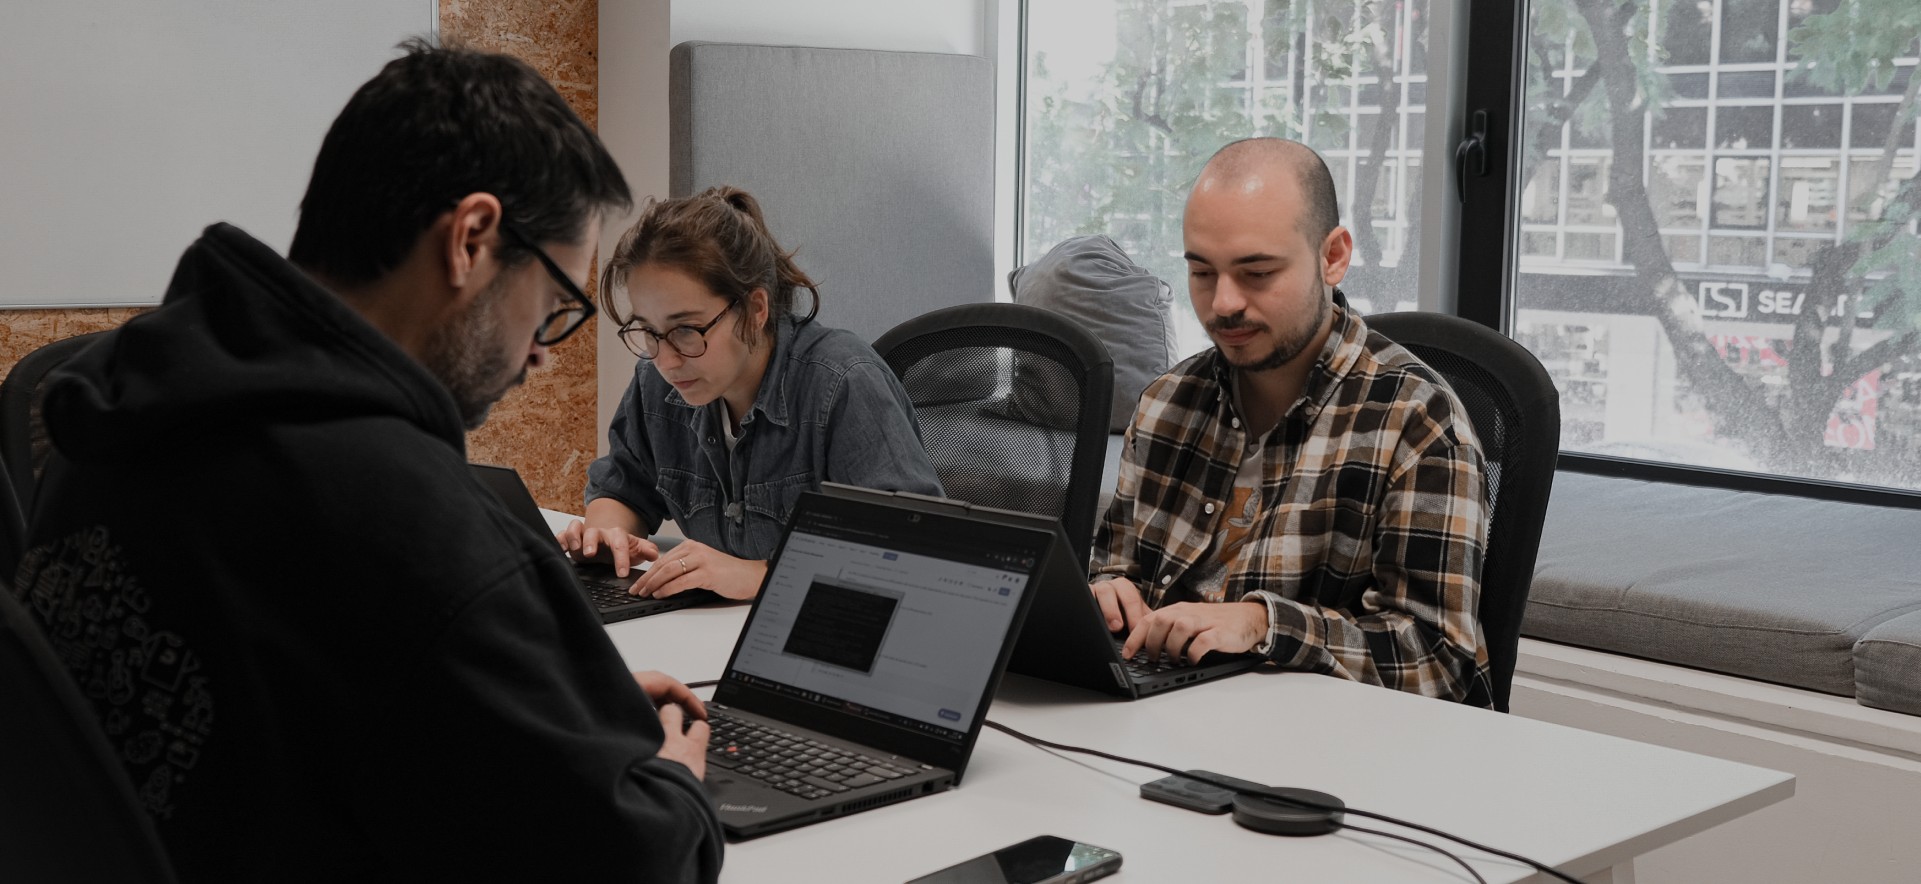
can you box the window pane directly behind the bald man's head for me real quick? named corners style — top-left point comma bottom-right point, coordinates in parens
top-left (1020, 0), bottom-right (1436, 354)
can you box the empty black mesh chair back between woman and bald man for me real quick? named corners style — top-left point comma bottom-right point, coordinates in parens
top-left (874, 304), bottom-right (1114, 565)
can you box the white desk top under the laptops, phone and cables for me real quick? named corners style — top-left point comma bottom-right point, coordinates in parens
top-left (607, 605), bottom-right (1794, 884)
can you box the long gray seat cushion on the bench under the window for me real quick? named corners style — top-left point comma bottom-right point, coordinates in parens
top-left (1521, 473), bottom-right (1921, 696)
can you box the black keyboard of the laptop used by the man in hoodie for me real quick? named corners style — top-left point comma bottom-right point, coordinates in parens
top-left (707, 707), bottom-right (914, 799)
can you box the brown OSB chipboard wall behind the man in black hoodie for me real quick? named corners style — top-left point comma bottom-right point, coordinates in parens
top-left (0, 0), bottom-right (599, 511)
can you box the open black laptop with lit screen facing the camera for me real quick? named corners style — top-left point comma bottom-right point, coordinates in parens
top-left (705, 492), bottom-right (1045, 840)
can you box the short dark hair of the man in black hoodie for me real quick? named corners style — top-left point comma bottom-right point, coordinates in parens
top-left (286, 38), bottom-right (634, 286)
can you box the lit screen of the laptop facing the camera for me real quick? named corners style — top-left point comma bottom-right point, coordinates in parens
top-left (730, 525), bottom-right (1033, 740)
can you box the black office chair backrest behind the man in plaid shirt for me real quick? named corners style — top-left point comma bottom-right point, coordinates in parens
top-left (1366, 313), bottom-right (1560, 711)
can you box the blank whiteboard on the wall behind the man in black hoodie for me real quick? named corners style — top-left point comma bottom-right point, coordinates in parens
top-left (0, 0), bottom-right (438, 307)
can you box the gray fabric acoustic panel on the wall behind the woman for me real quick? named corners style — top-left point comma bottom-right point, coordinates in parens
top-left (669, 42), bottom-right (995, 342)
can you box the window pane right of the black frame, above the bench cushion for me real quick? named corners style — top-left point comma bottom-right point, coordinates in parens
top-left (1508, 0), bottom-right (1921, 490)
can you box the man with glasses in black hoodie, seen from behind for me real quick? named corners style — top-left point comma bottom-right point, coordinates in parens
top-left (15, 44), bottom-right (720, 882)
